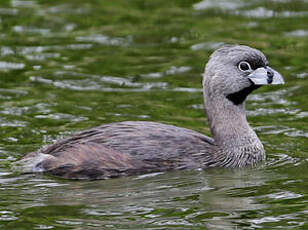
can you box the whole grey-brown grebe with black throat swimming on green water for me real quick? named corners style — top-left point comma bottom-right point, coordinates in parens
top-left (13, 45), bottom-right (284, 180)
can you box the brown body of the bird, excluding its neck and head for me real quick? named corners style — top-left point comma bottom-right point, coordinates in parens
top-left (24, 122), bottom-right (216, 179)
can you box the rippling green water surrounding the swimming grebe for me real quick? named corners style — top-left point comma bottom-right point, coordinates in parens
top-left (0, 0), bottom-right (308, 230)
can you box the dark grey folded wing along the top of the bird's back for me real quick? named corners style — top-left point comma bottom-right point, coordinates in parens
top-left (41, 121), bottom-right (214, 160)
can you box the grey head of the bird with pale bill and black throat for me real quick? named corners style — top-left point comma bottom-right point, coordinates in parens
top-left (203, 45), bottom-right (284, 104)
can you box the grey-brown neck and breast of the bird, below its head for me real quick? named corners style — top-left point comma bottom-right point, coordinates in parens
top-left (204, 90), bottom-right (264, 167)
